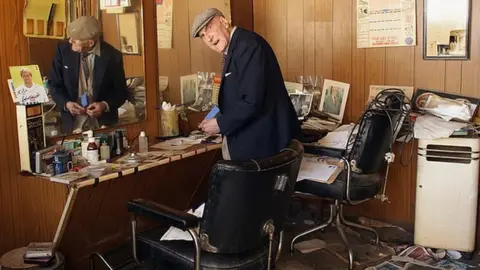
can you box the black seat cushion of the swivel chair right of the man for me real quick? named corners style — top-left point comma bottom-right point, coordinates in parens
top-left (295, 171), bottom-right (382, 201)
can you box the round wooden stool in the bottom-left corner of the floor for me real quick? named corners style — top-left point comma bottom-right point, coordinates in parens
top-left (0, 247), bottom-right (65, 270)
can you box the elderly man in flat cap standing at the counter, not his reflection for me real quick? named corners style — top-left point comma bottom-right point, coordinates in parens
top-left (192, 8), bottom-right (300, 160)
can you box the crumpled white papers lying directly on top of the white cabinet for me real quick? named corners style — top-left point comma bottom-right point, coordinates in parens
top-left (414, 115), bottom-right (467, 140)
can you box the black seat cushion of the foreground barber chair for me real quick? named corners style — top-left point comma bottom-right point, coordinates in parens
top-left (137, 229), bottom-right (268, 270)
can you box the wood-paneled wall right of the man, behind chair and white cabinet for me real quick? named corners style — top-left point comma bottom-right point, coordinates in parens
top-left (254, 0), bottom-right (480, 224)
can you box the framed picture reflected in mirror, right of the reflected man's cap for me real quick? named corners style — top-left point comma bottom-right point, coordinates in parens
top-left (117, 12), bottom-right (142, 55)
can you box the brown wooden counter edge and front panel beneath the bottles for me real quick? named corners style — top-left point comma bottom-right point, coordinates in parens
top-left (45, 144), bottom-right (221, 269)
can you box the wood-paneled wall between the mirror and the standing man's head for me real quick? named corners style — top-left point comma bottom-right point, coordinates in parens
top-left (158, 0), bottom-right (253, 104)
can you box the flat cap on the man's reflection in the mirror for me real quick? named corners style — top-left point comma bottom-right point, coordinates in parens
top-left (67, 16), bottom-right (102, 40)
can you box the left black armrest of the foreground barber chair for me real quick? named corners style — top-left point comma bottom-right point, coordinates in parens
top-left (127, 199), bottom-right (199, 230)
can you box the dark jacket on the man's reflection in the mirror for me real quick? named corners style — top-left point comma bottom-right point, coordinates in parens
top-left (49, 41), bottom-right (128, 133)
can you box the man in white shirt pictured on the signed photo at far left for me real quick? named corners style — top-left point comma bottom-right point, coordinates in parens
top-left (15, 67), bottom-right (48, 104)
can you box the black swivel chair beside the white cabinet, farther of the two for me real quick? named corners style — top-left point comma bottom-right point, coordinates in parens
top-left (290, 89), bottom-right (411, 269)
